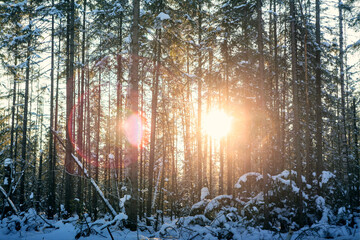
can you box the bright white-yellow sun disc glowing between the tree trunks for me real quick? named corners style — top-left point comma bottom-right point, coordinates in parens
top-left (203, 109), bottom-right (232, 140)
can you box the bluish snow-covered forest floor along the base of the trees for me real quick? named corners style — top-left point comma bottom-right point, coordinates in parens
top-left (0, 209), bottom-right (360, 240)
